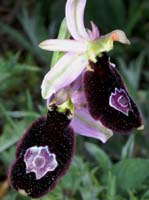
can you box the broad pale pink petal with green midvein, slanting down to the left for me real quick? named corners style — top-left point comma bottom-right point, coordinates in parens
top-left (41, 53), bottom-right (88, 99)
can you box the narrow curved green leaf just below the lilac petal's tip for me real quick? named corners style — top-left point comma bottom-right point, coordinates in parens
top-left (85, 142), bottom-right (111, 172)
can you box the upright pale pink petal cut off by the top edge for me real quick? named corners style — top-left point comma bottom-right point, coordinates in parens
top-left (66, 0), bottom-right (90, 40)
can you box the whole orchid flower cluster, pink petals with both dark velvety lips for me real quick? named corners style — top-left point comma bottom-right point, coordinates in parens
top-left (9, 0), bottom-right (142, 198)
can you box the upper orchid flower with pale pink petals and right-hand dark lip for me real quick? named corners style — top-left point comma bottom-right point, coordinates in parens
top-left (39, 0), bottom-right (142, 138)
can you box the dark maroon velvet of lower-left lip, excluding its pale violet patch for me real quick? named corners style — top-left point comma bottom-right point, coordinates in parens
top-left (9, 107), bottom-right (75, 198)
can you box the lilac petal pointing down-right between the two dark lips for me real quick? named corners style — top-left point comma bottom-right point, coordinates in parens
top-left (70, 108), bottom-right (113, 143)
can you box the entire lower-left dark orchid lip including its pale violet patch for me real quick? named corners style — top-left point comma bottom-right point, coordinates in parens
top-left (9, 108), bottom-right (75, 198)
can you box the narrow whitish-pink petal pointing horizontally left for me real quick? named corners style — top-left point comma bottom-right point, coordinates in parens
top-left (39, 39), bottom-right (87, 53)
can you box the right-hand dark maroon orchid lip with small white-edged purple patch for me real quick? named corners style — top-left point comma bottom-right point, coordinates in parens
top-left (83, 54), bottom-right (142, 133)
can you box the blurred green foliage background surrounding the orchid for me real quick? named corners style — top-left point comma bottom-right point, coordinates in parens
top-left (0, 0), bottom-right (149, 200)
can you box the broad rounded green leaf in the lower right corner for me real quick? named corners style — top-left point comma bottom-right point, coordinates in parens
top-left (111, 158), bottom-right (149, 191)
